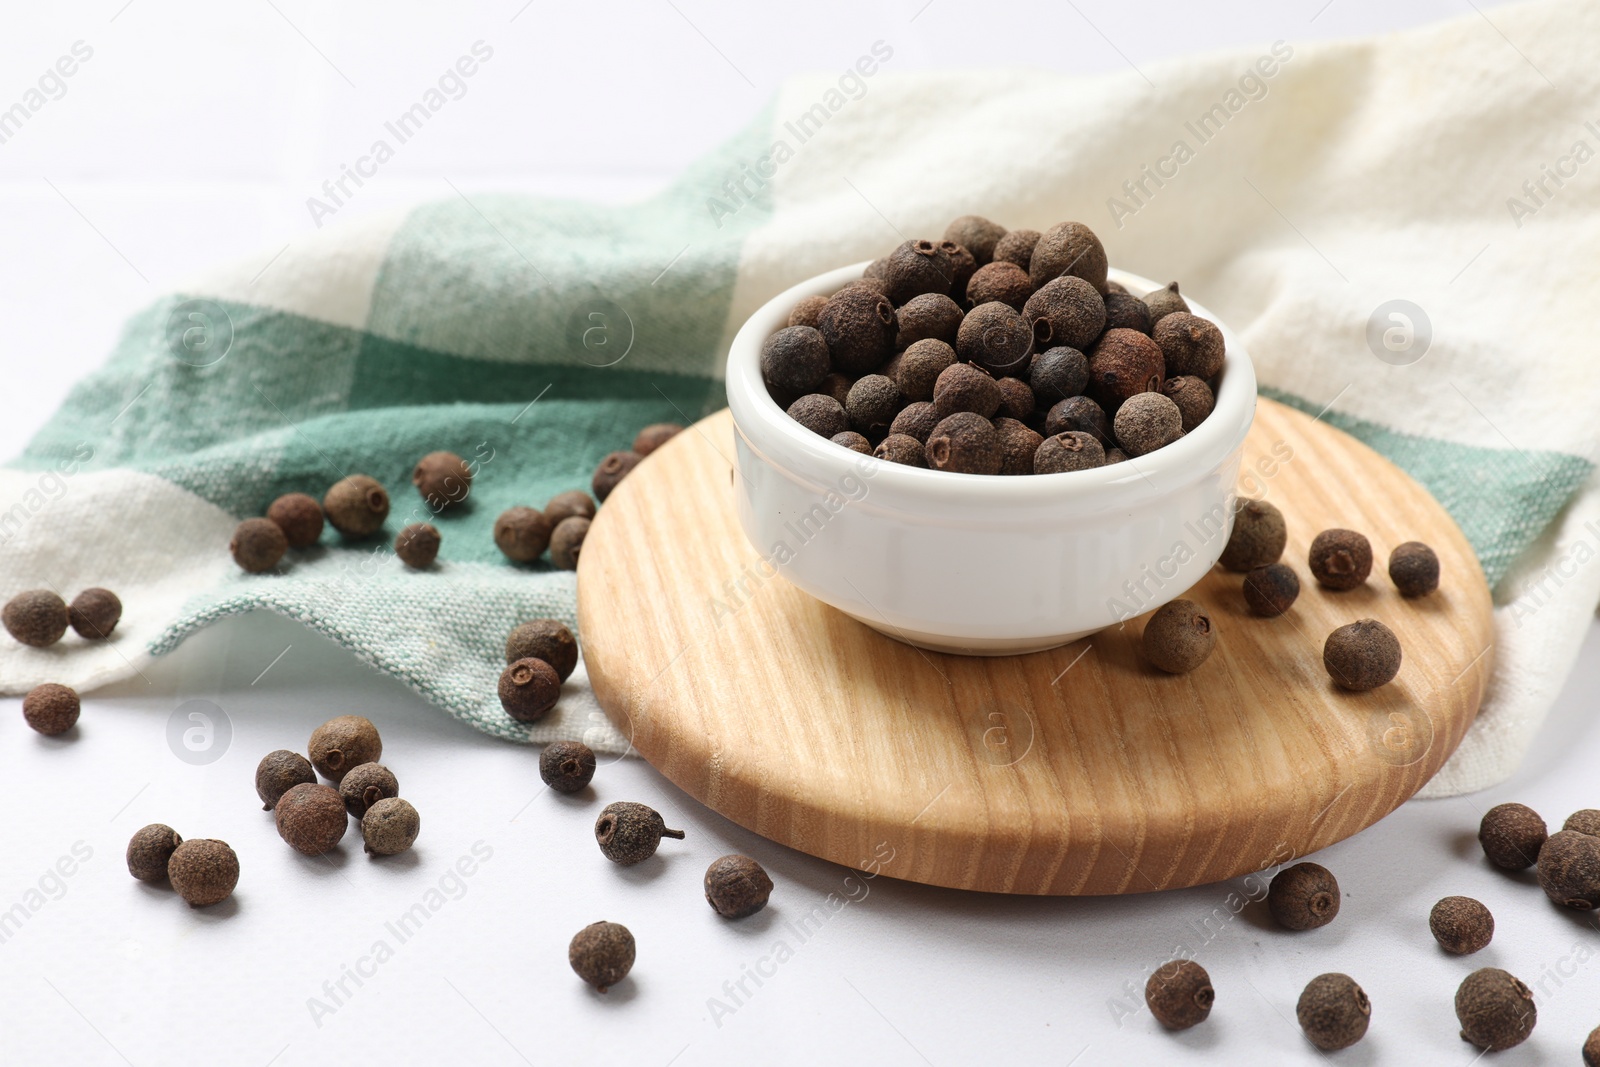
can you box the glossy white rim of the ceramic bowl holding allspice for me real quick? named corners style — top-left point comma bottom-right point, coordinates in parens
top-left (725, 259), bottom-right (1256, 507)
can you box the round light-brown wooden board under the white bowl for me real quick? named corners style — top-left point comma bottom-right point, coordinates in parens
top-left (578, 400), bottom-right (1493, 894)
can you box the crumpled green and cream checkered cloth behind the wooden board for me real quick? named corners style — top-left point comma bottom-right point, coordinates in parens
top-left (0, 0), bottom-right (1600, 793)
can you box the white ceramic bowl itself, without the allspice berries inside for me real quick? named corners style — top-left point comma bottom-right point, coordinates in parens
top-left (726, 264), bottom-right (1256, 656)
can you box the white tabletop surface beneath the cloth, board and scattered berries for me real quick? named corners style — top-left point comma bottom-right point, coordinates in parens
top-left (0, 0), bottom-right (1600, 1067)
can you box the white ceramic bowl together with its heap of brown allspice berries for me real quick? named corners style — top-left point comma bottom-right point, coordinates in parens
top-left (726, 216), bottom-right (1256, 654)
